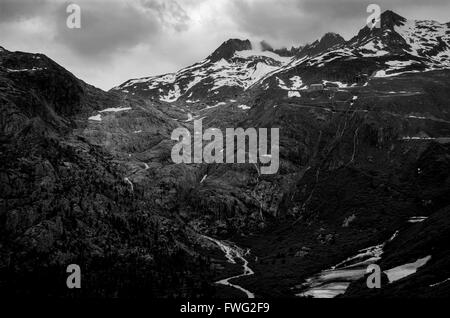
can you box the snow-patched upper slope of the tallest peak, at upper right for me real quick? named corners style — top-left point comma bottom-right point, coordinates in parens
top-left (261, 11), bottom-right (450, 90)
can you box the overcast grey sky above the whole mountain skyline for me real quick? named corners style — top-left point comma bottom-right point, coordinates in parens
top-left (0, 0), bottom-right (450, 90)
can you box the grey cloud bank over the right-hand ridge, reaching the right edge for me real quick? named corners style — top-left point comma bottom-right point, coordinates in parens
top-left (230, 0), bottom-right (450, 45)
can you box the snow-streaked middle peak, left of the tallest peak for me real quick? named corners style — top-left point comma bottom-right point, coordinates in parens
top-left (113, 39), bottom-right (291, 103)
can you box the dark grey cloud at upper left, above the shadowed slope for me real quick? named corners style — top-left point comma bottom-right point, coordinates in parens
top-left (0, 0), bottom-right (189, 59)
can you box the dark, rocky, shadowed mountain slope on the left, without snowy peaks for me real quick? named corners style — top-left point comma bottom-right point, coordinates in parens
top-left (0, 46), bottom-right (214, 298)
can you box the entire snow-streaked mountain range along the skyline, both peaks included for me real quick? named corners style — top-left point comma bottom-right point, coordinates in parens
top-left (113, 11), bottom-right (450, 103)
